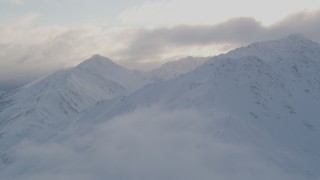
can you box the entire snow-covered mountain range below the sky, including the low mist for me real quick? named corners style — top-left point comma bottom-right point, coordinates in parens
top-left (0, 35), bottom-right (320, 180)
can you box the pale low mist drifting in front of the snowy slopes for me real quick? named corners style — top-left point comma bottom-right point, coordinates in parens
top-left (0, 107), bottom-right (303, 180)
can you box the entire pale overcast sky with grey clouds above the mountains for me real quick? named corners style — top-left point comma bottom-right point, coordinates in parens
top-left (0, 0), bottom-right (320, 91)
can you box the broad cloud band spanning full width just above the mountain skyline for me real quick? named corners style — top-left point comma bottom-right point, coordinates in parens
top-left (0, 10), bottom-right (320, 90)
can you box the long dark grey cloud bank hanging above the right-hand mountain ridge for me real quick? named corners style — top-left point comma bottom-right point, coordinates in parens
top-left (123, 10), bottom-right (320, 59)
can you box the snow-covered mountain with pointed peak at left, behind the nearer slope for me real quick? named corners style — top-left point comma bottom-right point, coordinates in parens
top-left (0, 55), bottom-right (147, 166)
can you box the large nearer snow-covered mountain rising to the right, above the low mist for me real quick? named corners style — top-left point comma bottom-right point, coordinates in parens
top-left (67, 35), bottom-right (320, 179)
